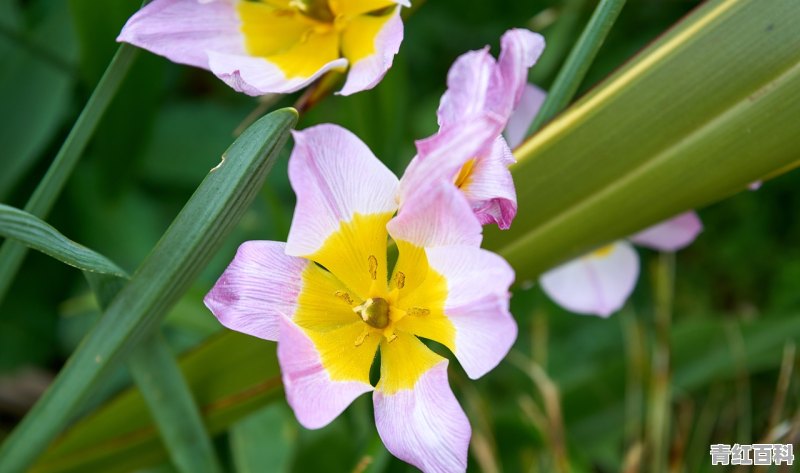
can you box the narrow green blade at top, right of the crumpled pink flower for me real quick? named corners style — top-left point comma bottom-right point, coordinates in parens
top-left (528, 0), bottom-right (625, 135)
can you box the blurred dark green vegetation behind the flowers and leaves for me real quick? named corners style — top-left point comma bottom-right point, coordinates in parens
top-left (0, 0), bottom-right (800, 472)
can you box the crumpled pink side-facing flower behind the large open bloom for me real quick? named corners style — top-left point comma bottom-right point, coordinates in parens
top-left (400, 29), bottom-right (544, 229)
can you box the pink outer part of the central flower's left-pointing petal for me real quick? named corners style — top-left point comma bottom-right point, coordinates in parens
top-left (203, 241), bottom-right (309, 341)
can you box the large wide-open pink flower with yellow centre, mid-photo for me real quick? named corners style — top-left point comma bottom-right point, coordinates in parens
top-left (205, 125), bottom-right (517, 472)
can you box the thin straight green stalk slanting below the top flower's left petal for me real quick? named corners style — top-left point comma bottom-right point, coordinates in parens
top-left (0, 44), bottom-right (138, 301)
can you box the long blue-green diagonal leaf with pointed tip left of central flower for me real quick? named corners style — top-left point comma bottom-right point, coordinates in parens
top-left (0, 109), bottom-right (297, 472)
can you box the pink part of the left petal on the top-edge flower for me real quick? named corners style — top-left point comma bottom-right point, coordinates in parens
top-left (117, 0), bottom-right (245, 69)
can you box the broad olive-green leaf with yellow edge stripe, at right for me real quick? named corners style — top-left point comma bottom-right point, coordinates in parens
top-left (486, 0), bottom-right (800, 281)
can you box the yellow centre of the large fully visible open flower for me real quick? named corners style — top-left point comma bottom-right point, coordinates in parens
top-left (293, 212), bottom-right (456, 392)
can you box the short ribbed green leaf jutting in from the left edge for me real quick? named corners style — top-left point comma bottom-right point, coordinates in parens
top-left (0, 204), bottom-right (128, 278)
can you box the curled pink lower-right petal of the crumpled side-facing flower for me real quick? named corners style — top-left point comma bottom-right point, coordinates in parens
top-left (461, 137), bottom-right (517, 230)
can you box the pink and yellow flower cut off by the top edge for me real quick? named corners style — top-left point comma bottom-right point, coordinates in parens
top-left (117, 0), bottom-right (408, 95)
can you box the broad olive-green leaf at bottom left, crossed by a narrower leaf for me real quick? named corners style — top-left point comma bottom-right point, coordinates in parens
top-left (32, 332), bottom-right (283, 473)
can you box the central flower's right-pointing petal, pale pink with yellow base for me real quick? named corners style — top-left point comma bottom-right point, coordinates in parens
top-left (397, 246), bottom-right (517, 379)
